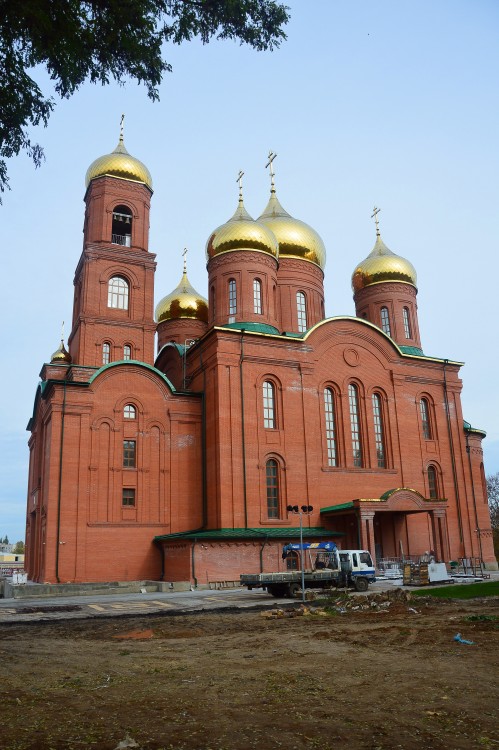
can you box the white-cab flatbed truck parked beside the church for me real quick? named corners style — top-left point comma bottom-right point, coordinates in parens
top-left (240, 542), bottom-right (376, 597)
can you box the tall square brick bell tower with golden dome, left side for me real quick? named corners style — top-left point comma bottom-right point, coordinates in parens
top-left (68, 123), bottom-right (156, 367)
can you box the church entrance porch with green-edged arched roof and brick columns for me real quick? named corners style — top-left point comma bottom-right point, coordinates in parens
top-left (321, 488), bottom-right (451, 564)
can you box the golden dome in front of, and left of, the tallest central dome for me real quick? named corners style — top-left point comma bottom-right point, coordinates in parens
top-left (206, 197), bottom-right (279, 260)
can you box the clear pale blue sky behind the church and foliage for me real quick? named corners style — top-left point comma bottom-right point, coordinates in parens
top-left (0, 0), bottom-right (499, 540)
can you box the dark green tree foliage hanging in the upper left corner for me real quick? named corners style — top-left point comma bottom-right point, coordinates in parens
top-left (0, 0), bottom-right (289, 198)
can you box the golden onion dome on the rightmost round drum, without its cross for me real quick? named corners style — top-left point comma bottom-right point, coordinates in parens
top-left (352, 234), bottom-right (418, 292)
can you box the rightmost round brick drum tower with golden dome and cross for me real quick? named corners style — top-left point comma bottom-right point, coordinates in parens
top-left (352, 208), bottom-right (421, 349)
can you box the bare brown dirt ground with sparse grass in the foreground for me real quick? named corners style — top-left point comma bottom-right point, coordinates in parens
top-left (0, 597), bottom-right (499, 750)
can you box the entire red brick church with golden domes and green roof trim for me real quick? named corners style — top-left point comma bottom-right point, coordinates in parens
top-left (26, 136), bottom-right (497, 585)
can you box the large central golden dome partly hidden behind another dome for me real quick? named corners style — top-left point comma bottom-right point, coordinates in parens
top-left (258, 190), bottom-right (326, 270)
